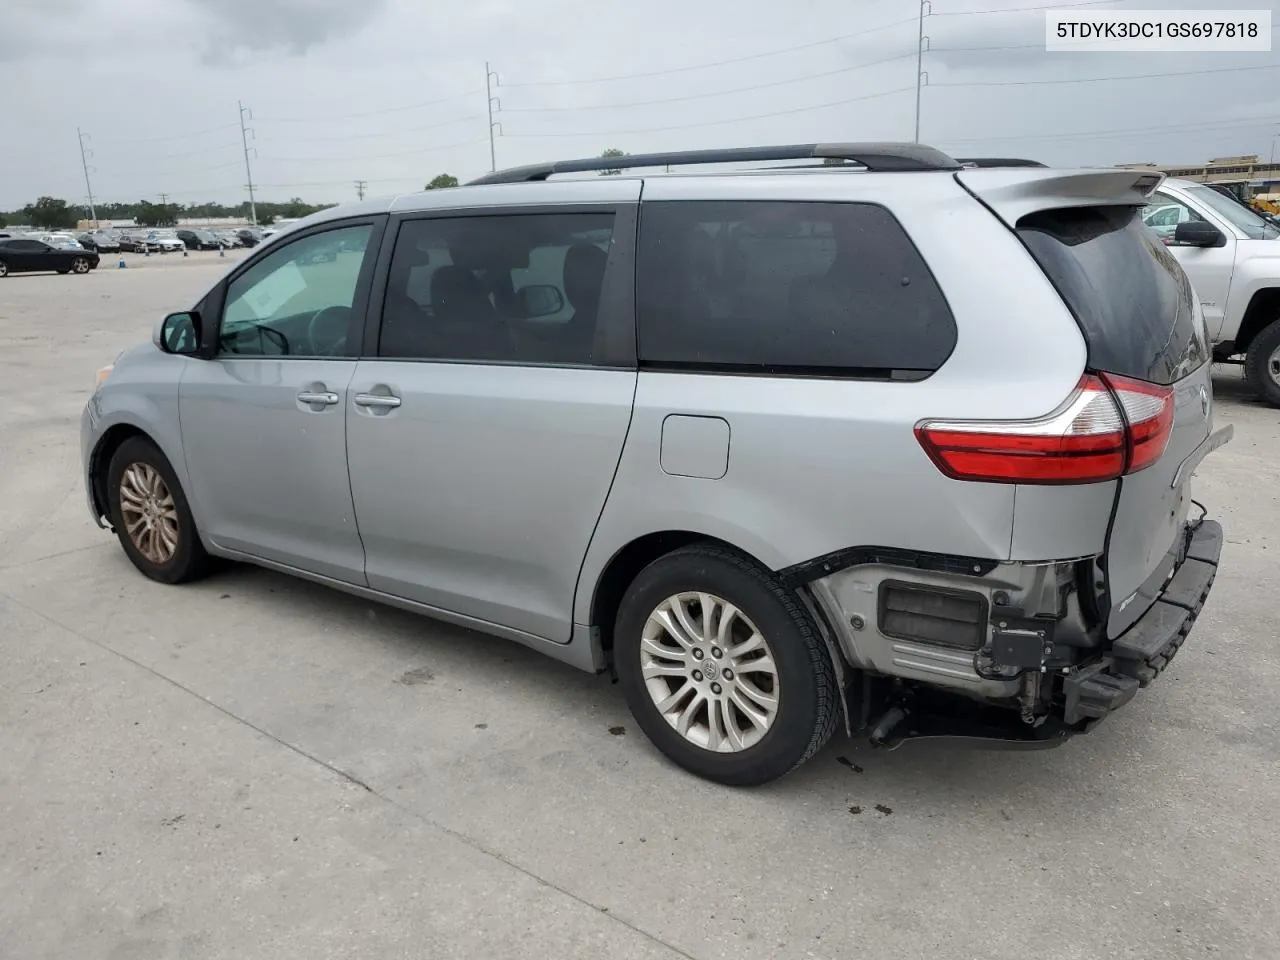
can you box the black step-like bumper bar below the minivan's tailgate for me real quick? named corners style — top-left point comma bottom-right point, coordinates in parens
top-left (1062, 520), bottom-right (1222, 724)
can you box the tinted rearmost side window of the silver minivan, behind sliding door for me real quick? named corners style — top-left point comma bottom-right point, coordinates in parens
top-left (636, 201), bottom-right (956, 378)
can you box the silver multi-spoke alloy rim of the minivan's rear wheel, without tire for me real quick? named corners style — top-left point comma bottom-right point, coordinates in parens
top-left (640, 593), bottom-right (780, 753)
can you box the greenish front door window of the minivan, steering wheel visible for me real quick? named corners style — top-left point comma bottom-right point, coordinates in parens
top-left (218, 224), bottom-right (374, 357)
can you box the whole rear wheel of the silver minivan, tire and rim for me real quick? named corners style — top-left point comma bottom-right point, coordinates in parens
top-left (613, 544), bottom-right (840, 786)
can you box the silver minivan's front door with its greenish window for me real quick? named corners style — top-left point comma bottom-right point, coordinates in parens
top-left (179, 220), bottom-right (381, 584)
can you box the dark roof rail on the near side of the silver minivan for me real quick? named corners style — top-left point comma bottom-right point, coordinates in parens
top-left (471, 143), bottom-right (960, 184)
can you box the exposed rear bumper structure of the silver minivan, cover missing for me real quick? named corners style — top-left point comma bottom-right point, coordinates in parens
top-left (809, 520), bottom-right (1222, 749)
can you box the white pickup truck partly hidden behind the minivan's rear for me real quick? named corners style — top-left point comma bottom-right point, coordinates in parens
top-left (1143, 179), bottom-right (1280, 407)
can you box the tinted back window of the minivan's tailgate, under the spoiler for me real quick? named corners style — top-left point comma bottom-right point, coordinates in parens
top-left (1018, 206), bottom-right (1208, 384)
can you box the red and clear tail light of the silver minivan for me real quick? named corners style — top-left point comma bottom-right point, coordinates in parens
top-left (915, 374), bottom-right (1174, 484)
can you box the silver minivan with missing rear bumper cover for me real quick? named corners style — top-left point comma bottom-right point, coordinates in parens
top-left (82, 143), bottom-right (1231, 785)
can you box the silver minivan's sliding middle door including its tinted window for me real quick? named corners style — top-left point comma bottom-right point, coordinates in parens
top-left (347, 204), bottom-right (636, 643)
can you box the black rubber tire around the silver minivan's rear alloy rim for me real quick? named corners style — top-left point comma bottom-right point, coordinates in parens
top-left (613, 544), bottom-right (840, 786)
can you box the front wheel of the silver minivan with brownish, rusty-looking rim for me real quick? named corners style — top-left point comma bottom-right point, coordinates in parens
top-left (106, 436), bottom-right (210, 584)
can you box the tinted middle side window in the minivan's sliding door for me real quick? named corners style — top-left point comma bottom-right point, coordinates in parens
top-left (378, 212), bottom-right (613, 364)
